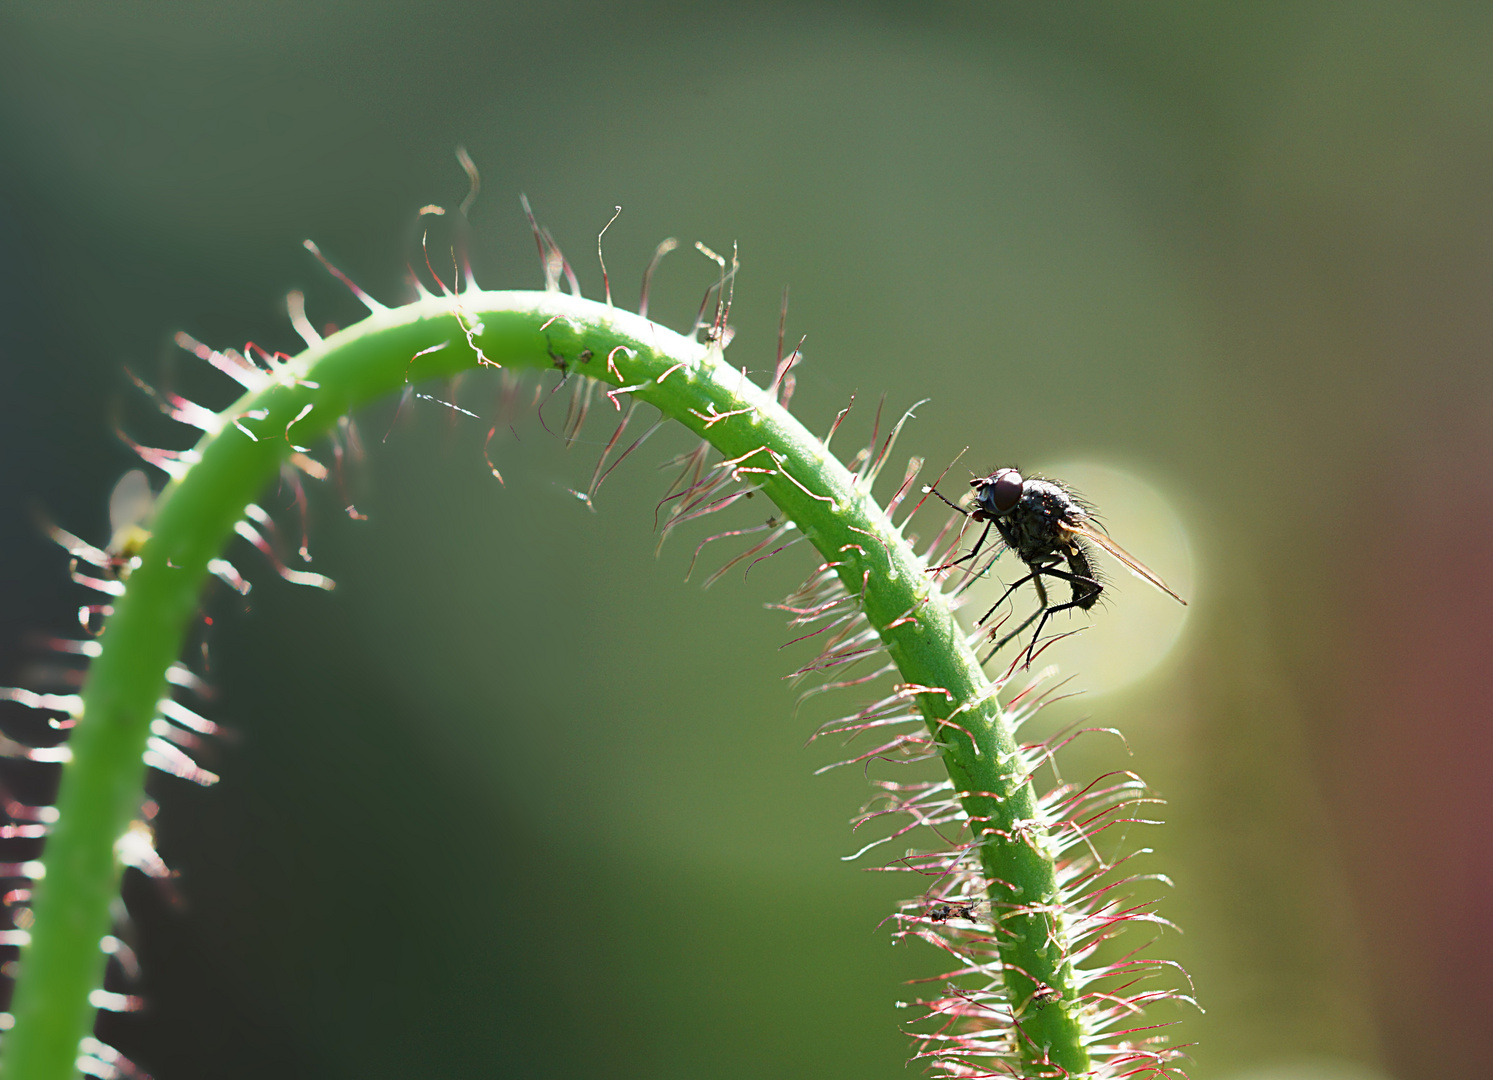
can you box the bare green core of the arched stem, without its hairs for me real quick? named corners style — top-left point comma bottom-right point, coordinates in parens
top-left (0, 291), bottom-right (1088, 1080)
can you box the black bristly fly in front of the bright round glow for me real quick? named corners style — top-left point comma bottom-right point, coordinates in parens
top-left (924, 469), bottom-right (1187, 668)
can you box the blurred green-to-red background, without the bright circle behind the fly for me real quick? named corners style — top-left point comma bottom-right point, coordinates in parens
top-left (0, 0), bottom-right (1493, 1080)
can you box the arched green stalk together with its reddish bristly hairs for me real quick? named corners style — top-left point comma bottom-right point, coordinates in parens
top-left (0, 221), bottom-right (1175, 1080)
